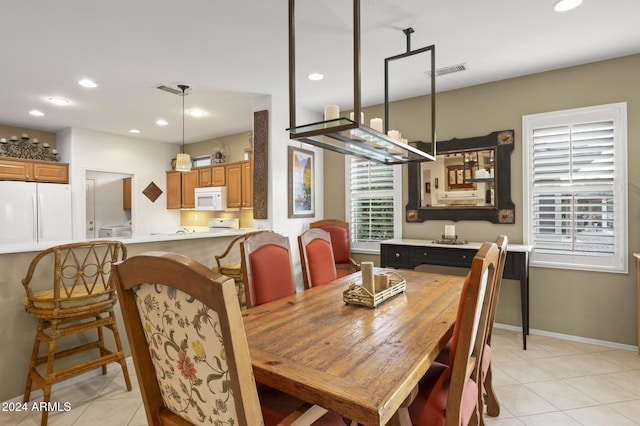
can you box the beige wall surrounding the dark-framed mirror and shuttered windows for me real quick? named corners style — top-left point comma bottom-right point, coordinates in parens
top-left (324, 55), bottom-right (640, 345)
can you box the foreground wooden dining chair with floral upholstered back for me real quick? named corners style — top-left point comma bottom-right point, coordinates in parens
top-left (113, 252), bottom-right (342, 426)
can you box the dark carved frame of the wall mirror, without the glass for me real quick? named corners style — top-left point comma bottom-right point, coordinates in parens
top-left (406, 130), bottom-right (516, 224)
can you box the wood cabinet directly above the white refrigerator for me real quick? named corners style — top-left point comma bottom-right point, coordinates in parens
top-left (0, 157), bottom-right (69, 183)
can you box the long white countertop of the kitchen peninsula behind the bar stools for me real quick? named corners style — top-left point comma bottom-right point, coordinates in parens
top-left (0, 228), bottom-right (255, 254)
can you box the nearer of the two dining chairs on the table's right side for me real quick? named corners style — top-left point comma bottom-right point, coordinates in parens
top-left (409, 242), bottom-right (500, 426)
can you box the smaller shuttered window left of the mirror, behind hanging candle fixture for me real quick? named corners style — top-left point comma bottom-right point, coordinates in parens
top-left (345, 156), bottom-right (402, 252)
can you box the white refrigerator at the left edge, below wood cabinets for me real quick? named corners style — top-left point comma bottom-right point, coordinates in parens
top-left (0, 181), bottom-right (72, 245)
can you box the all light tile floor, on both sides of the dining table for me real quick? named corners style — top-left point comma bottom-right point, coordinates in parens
top-left (0, 329), bottom-right (640, 426)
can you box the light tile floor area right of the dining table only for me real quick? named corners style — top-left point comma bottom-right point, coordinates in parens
top-left (485, 329), bottom-right (640, 426)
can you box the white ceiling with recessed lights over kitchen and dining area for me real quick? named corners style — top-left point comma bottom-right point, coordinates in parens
top-left (0, 0), bottom-right (640, 143)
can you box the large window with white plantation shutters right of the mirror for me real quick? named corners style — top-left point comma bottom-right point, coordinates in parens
top-left (522, 103), bottom-right (628, 273)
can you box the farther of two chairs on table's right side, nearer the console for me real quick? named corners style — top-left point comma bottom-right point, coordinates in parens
top-left (436, 235), bottom-right (508, 425)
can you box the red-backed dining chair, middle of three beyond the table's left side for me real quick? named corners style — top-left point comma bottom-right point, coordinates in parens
top-left (298, 228), bottom-right (338, 289)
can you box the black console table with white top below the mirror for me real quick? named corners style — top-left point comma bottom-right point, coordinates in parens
top-left (380, 239), bottom-right (533, 349)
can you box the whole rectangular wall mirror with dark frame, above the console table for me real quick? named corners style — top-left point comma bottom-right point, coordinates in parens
top-left (406, 130), bottom-right (515, 223)
